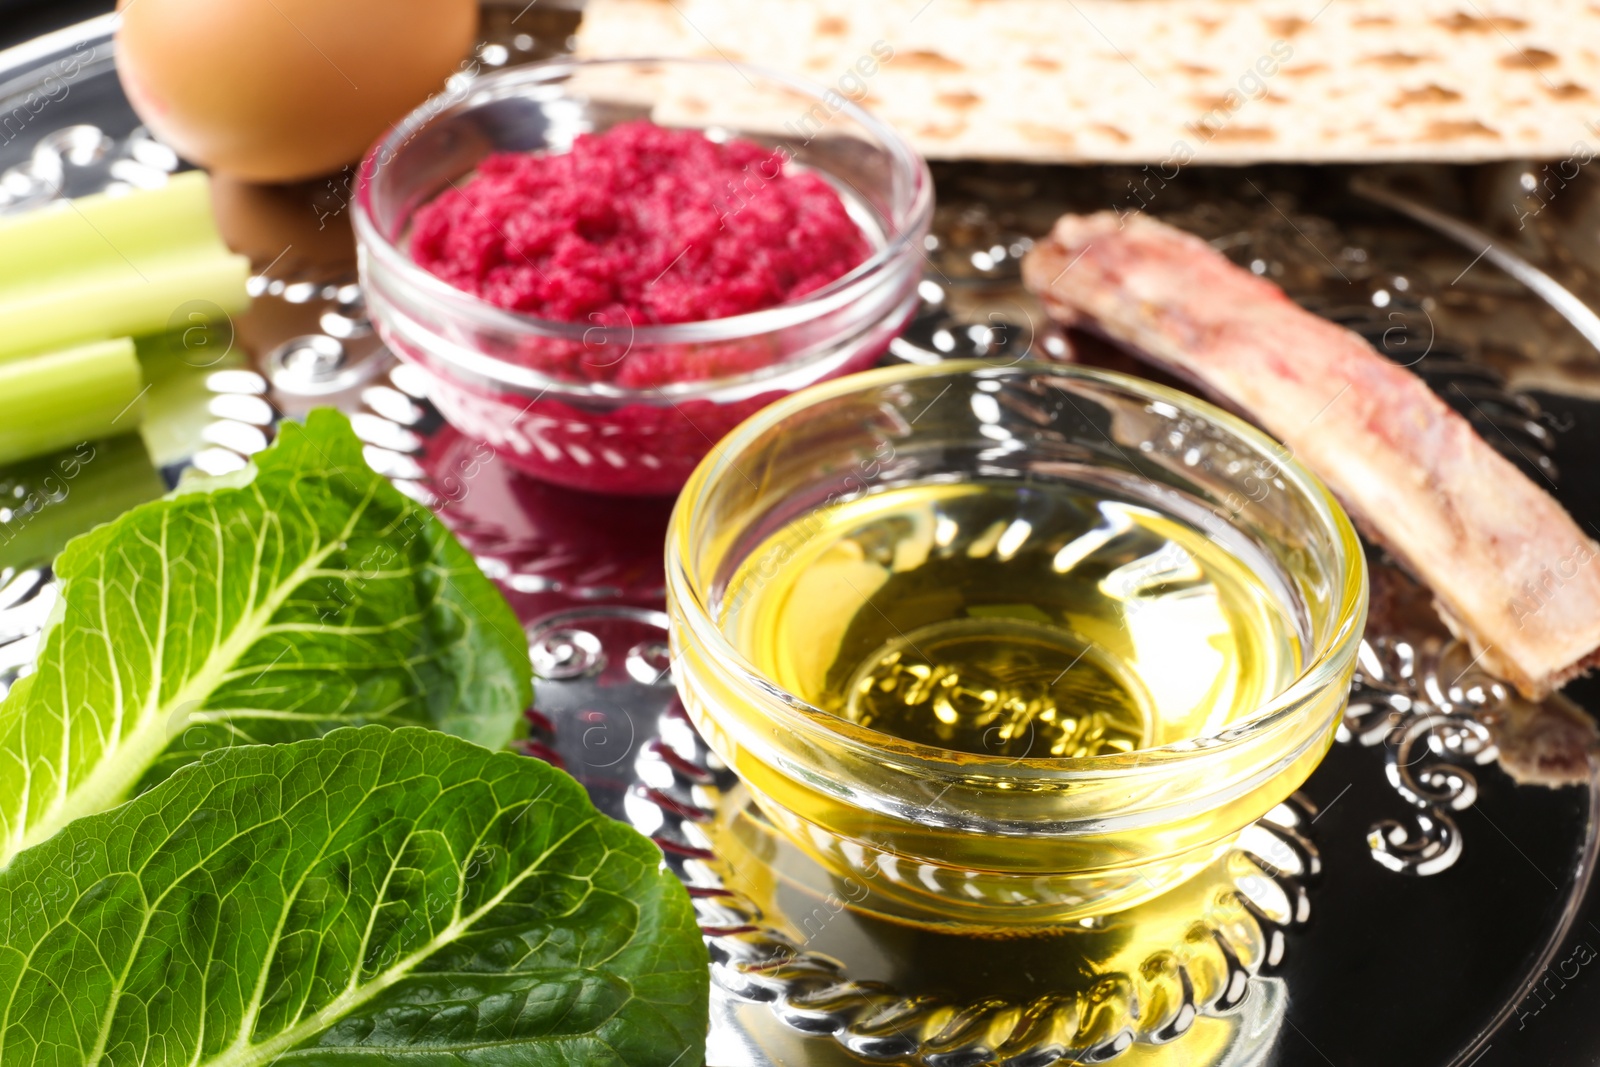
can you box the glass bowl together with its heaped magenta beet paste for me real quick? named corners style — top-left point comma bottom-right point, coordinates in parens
top-left (354, 59), bottom-right (933, 494)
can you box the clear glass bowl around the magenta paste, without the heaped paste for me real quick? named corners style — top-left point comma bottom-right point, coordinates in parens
top-left (354, 59), bottom-right (933, 494)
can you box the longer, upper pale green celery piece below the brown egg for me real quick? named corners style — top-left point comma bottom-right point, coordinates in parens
top-left (0, 171), bottom-right (250, 362)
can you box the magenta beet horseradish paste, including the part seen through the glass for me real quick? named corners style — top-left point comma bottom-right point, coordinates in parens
top-left (393, 120), bottom-right (882, 493)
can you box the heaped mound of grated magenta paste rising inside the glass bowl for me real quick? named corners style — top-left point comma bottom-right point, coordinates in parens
top-left (411, 122), bottom-right (870, 386)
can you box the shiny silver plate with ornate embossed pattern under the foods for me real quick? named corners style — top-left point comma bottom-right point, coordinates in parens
top-left (0, 5), bottom-right (1600, 1067)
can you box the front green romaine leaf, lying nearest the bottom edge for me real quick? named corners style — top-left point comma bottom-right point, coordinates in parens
top-left (0, 726), bottom-right (709, 1067)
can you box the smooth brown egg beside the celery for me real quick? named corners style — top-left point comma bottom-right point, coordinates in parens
top-left (117, 0), bottom-right (478, 181)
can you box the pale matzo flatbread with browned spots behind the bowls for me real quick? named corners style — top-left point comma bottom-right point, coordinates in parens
top-left (578, 0), bottom-right (1600, 166)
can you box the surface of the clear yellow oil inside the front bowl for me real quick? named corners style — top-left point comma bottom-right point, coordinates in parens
top-left (723, 480), bottom-right (1301, 760)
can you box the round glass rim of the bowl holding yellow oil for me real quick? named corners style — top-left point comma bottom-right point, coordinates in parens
top-left (666, 360), bottom-right (1368, 779)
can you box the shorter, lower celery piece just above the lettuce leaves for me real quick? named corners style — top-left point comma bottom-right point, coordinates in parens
top-left (0, 338), bottom-right (144, 464)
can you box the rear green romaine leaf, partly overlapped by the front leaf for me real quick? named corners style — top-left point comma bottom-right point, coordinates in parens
top-left (0, 410), bottom-right (531, 867)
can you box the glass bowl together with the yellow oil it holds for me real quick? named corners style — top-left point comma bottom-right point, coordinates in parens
top-left (667, 362), bottom-right (1366, 931)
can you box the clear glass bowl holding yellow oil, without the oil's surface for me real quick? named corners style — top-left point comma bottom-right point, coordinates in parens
top-left (667, 363), bottom-right (1366, 926)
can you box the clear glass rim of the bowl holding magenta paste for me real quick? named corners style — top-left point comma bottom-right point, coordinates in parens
top-left (350, 56), bottom-right (933, 402)
